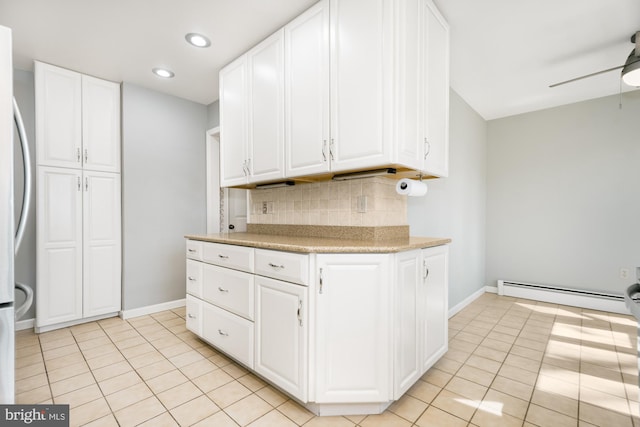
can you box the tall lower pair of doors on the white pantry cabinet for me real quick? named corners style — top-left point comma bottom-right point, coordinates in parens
top-left (36, 167), bottom-right (121, 330)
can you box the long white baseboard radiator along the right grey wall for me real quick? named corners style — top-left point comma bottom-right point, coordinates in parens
top-left (498, 280), bottom-right (629, 314)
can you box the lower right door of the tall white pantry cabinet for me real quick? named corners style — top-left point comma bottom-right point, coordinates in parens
top-left (83, 172), bottom-right (122, 317)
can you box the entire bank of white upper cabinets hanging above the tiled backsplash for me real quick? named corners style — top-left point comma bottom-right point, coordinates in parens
top-left (220, 0), bottom-right (449, 186)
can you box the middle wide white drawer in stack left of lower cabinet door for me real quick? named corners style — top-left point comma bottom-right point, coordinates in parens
top-left (202, 264), bottom-right (254, 320)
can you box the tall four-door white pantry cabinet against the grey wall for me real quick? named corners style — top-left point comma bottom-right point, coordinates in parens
top-left (35, 61), bottom-right (121, 332)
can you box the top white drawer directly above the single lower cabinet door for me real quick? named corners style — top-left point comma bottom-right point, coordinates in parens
top-left (255, 249), bottom-right (309, 285)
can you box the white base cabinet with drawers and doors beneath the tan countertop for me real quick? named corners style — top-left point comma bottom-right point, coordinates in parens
top-left (186, 235), bottom-right (448, 415)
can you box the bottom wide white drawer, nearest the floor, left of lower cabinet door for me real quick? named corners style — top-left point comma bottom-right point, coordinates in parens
top-left (202, 302), bottom-right (253, 369)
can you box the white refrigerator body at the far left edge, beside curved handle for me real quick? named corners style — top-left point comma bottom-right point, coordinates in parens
top-left (0, 26), bottom-right (15, 404)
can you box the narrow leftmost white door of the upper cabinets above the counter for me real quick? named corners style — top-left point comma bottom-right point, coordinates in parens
top-left (220, 55), bottom-right (248, 187)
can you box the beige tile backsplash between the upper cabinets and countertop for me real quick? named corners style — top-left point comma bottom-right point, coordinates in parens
top-left (248, 177), bottom-right (407, 226)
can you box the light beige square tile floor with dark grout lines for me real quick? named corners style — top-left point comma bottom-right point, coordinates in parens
top-left (16, 294), bottom-right (640, 427)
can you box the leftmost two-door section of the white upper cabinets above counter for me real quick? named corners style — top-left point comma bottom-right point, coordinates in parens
top-left (220, 30), bottom-right (284, 187)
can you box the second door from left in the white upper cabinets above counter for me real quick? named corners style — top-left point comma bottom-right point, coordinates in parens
top-left (247, 30), bottom-right (284, 182)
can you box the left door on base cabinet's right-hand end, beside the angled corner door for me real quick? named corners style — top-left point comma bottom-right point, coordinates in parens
top-left (393, 250), bottom-right (424, 399)
